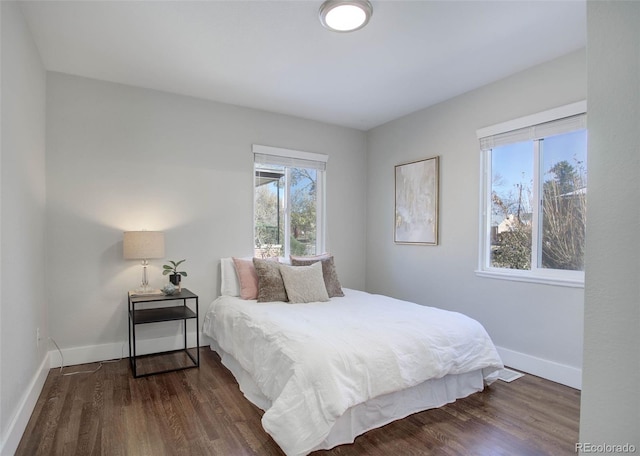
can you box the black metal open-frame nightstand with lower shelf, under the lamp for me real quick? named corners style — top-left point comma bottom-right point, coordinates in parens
top-left (128, 288), bottom-right (200, 378)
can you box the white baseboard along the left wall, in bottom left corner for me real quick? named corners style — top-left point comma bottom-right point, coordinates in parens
top-left (0, 353), bottom-right (49, 456)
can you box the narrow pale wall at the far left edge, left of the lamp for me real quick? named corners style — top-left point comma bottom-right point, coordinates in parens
top-left (0, 1), bottom-right (48, 454)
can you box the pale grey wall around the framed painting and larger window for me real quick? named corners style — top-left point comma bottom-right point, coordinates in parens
top-left (366, 50), bottom-right (586, 387)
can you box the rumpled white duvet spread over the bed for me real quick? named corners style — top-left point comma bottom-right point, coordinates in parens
top-left (204, 289), bottom-right (502, 455)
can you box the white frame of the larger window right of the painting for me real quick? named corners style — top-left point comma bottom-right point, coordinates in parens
top-left (476, 100), bottom-right (587, 288)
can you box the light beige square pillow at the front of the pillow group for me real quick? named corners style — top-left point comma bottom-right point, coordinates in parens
top-left (280, 261), bottom-right (329, 303)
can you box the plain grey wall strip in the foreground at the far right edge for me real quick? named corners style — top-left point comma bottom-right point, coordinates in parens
top-left (580, 1), bottom-right (640, 451)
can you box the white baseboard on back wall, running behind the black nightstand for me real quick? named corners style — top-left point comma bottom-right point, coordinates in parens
top-left (49, 332), bottom-right (202, 367)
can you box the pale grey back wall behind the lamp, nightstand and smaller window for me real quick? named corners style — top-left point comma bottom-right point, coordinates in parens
top-left (47, 73), bottom-right (366, 362)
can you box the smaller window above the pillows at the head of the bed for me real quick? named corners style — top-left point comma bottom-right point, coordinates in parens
top-left (253, 145), bottom-right (328, 258)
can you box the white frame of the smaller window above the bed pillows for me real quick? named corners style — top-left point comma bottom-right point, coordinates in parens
top-left (252, 144), bottom-right (329, 261)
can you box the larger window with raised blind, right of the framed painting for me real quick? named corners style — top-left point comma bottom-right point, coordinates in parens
top-left (478, 102), bottom-right (587, 286)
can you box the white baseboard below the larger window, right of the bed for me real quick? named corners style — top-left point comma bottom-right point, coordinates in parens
top-left (496, 347), bottom-right (582, 389)
